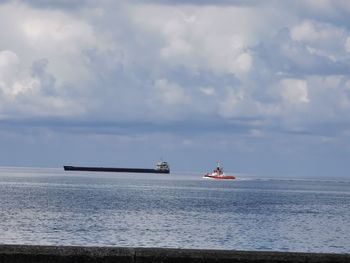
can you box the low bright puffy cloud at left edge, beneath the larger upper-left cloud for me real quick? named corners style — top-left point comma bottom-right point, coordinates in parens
top-left (0, 50), bottom-right (84, 118)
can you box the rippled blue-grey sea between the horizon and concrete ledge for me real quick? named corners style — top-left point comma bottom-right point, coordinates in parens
top-left (0, 167), bottom-right (350, 253)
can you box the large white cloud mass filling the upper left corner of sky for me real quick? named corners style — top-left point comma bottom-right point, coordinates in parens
top-left (0, 2), bottom-right (119, 117)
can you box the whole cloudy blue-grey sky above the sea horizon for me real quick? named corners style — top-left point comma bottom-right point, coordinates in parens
top-left (0, 0), bottom-right (350, 178)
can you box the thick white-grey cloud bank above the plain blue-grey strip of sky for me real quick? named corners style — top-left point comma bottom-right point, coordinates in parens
top-left (0, 0), bottom-right (350, 176)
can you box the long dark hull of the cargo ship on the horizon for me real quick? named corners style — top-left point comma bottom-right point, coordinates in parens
top-left (63, 165), bottom-right (170, 174)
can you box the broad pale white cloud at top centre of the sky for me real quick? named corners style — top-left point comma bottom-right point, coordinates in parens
top-left (133, 5), bottom-right (259, 76)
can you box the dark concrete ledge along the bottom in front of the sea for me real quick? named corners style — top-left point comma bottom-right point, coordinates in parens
top-left (0, 245), bottom-right (350, 263)
